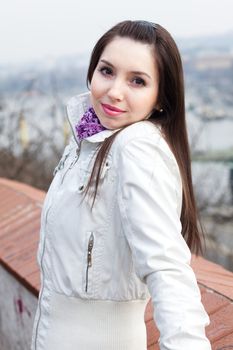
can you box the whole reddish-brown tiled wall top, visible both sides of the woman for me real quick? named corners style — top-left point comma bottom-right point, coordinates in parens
top-left (0, 178), bottom-right (233, 350)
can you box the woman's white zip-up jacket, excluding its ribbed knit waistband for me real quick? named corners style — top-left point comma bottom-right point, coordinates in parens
top-left (32, 93), bottom-right (211, 350)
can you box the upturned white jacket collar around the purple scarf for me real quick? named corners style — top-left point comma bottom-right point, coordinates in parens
top-left (66, 91), bottom-right (119, 143)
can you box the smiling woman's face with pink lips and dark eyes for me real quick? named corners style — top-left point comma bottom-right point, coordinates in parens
top-left (90, 37), bottom-right (159, 129)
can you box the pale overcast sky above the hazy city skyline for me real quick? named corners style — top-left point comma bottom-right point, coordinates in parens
top-left (0, 0), bottom-right (233, 63)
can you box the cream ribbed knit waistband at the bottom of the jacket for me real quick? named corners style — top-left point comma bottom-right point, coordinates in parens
top-left (45, 294), bottom-right (148, 350)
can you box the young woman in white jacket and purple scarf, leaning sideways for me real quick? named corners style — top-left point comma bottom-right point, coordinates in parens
top-left (31, 21), bottom-right (211, 350)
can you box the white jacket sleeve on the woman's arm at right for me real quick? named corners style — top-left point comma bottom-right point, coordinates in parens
top-left (117, 136), bottom-right (211, 350)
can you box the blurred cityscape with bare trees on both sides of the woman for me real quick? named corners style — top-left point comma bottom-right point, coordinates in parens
top-left (0, 32), bottom-right (233, 269)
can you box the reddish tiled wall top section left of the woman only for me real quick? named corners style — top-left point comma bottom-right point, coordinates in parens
top-left (0, 178), bottom-right (45, 295)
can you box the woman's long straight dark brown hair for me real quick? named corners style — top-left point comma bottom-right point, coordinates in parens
top-left (86, 21), bottom-right (203, 254)
